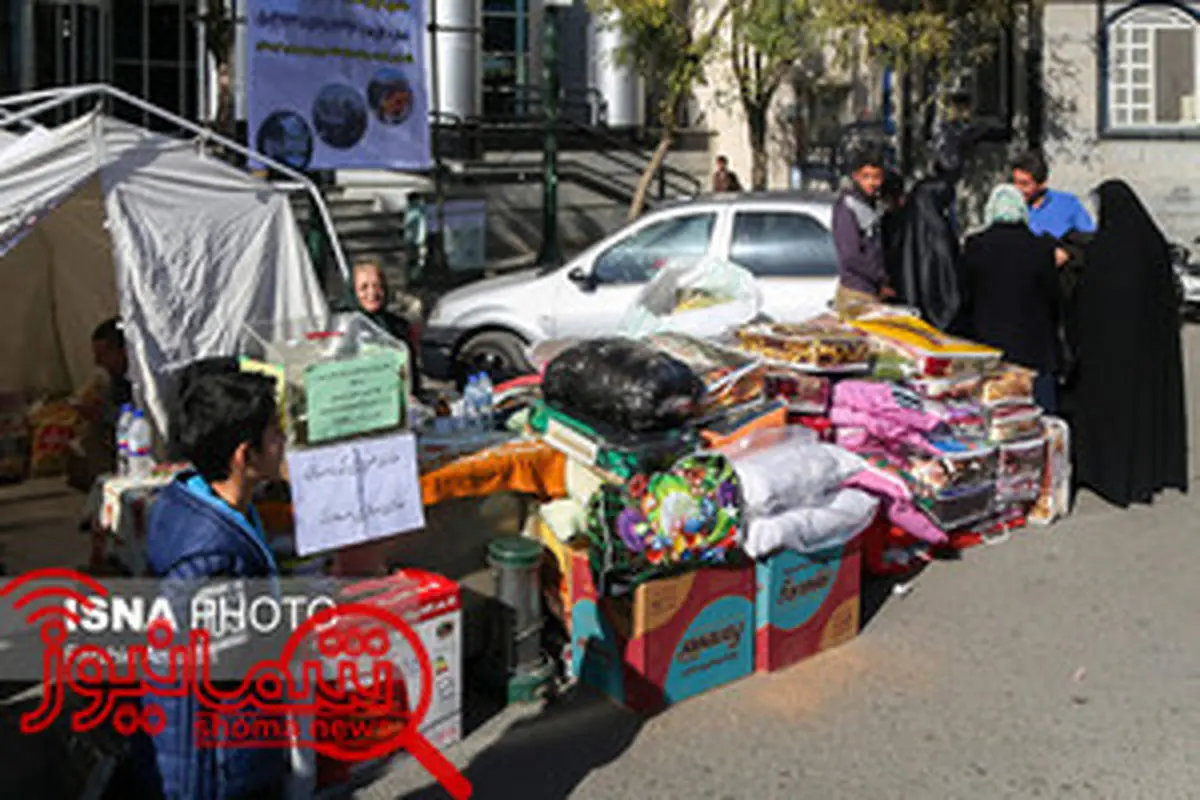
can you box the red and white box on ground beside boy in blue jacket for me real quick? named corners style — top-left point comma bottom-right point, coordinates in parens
top-left (318, 570), bottom-right (463, 784)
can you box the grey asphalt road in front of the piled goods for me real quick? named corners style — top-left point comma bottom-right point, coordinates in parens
top-left (369, 330), bottom-right (1200, 800)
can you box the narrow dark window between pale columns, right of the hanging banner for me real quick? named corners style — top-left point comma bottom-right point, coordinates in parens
top-left (484, 0), bottom-right (534, 119)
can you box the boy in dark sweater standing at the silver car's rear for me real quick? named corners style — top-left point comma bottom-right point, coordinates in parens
top-left (833, 149), bottom-right (894, 317)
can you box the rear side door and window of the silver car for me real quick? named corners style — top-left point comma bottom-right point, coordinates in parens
top-left (730, 207), bottom-right (838, 321)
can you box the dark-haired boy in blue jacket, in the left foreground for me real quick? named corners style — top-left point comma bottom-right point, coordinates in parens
top-left (146, 373), bottom-right (287, 800)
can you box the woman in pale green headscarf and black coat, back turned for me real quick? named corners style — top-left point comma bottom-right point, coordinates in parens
top-left (962, 185), bottom-right (1061, 414)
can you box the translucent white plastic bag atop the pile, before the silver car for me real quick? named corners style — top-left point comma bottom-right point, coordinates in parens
top-left (618, 255), bottom-right (762, 338)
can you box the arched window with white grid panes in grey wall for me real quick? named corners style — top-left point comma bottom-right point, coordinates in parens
top-left (1106, 5), bottom-right (1200, 131)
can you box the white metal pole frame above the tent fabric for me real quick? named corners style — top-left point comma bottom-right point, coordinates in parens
top-left (0, 84), bottom-right (350, 282)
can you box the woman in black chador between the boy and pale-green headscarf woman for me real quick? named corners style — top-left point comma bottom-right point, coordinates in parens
top-left (892, 178), bottom-right (962, 330)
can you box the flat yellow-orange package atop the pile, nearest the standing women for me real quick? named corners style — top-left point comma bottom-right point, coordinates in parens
top-left (850, 317), bottom-right (1003, 378)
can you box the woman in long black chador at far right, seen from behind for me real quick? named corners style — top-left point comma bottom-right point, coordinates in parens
top-left (1072, 181), bottom-right (1188, 507)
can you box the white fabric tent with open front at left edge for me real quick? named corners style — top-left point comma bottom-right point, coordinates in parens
top-left (0, 112), bottom-right (328, 431)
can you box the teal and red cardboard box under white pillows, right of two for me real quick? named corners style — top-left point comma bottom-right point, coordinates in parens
top-left (755, 539), bottom-right (862, 672)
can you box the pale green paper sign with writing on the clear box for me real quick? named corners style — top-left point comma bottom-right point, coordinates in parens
top-left (305, 350), bottom-right (404, 444)
